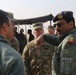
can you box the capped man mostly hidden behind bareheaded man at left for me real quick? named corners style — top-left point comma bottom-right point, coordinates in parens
top-left (3, 11), bottom-right (19, 52)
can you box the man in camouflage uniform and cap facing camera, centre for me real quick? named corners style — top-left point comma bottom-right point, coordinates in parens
top-left (22, 23), bottom-right (54, 75)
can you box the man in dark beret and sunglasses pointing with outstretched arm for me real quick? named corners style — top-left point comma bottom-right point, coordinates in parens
top-left (36, 11), bottom-right (76, 75)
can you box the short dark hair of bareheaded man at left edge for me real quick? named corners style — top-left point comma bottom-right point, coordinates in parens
top-left (0, 10), bottom-right (9, 28)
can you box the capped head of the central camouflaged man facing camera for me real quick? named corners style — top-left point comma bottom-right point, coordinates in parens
top-left (33, 22), bottom-right (44, 38)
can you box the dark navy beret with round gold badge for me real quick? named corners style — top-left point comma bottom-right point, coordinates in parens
top-left (53, 11), bottom-right (73, 22)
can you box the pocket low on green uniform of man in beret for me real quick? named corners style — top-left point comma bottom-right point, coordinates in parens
top-left (60, 58), bottom-right (72, 75)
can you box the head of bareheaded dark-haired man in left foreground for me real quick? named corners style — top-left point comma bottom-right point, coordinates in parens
top-left (0, 10), bottom-right (13, 41)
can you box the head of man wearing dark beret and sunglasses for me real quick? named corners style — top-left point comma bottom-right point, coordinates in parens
top-left (53, 11), bottom-right (75, 36)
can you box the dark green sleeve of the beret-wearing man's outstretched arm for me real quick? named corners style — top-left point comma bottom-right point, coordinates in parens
top-left (43, 34), bottom-right (60, 46)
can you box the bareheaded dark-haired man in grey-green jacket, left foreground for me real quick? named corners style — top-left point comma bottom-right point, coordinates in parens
top-left (0, 10), bottom-right (25, 75)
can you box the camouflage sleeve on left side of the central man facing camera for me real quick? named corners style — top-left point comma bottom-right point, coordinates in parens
top-left (22, 45), bottom-right (31, 75)
